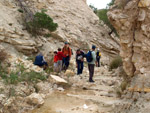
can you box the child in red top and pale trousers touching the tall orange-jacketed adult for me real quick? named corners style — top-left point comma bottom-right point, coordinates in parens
top-left (57, 48), bottom-right (64, 72)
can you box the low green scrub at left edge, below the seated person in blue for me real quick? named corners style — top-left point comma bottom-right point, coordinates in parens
top-left (0, 65), bottom-right (47, 84)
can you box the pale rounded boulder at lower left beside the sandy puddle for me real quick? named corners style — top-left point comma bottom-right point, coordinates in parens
top-left (26, 93), bottom-right (44, 106)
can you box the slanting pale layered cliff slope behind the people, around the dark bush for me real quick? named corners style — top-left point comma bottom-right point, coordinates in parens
top-left (0, 0), bottom-right (119, 60)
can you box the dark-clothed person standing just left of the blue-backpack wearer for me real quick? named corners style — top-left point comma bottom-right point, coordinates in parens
top-left (76, 49), bottom-right (84, 75)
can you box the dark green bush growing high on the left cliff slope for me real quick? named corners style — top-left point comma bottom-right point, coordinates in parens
top-left (26, 10), bottom-right (58, 35)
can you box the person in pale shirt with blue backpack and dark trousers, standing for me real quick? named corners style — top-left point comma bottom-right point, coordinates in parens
top-left (86, 45), bottom-right (96, 82)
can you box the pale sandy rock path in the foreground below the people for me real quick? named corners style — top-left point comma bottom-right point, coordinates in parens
top-left (32, 67), bottom-right (121, 113)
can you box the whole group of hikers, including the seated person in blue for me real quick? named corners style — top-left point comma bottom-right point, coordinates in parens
top-left (34, 42), bottom-right (101, 82)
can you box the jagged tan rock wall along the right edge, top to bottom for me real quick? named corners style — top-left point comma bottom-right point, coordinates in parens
top-left (108, 0), bottom-right (150, 113)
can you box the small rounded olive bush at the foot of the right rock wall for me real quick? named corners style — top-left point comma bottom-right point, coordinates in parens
top-left (109, 56), bottom-right (122, 70)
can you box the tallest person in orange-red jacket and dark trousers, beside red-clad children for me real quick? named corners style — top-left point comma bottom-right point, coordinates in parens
top-left (62, 42), bottom-right (72, 70)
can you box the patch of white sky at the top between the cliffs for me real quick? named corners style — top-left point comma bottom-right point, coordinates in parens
top-left (87, 0), bottom-right (111, 9)
